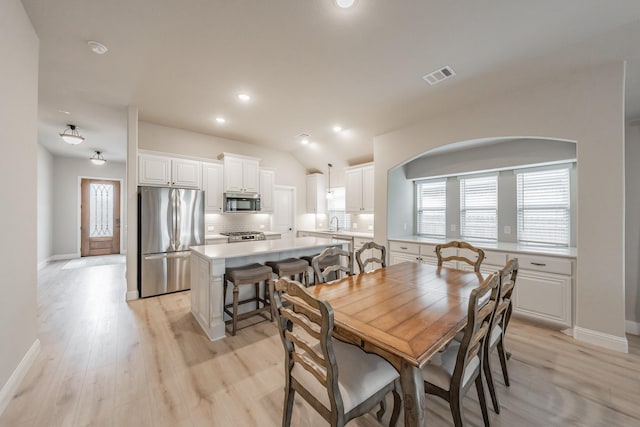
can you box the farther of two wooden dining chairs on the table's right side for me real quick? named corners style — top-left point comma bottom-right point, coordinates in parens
top-left (483, 258), bottom-right (518, 414)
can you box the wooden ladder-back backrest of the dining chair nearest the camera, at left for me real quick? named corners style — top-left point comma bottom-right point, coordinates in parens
top-left (269, 278), bottom-right (344, 418)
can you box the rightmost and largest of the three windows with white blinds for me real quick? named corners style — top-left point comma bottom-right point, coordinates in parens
top-left (516, 165), bottom-right (571, 246)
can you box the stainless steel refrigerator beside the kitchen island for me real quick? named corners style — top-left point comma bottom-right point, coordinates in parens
top-left (138, 187), bottom-right (204, 297)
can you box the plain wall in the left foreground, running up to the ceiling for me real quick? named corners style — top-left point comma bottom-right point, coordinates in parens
top-left (0, 0), bottom-right (39, 412)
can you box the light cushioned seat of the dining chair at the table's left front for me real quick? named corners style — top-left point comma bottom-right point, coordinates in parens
top-left (291, 339), bottom-right (399, 412)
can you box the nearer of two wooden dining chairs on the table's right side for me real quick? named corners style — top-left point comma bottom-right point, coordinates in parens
top-left (422, 273), bottom-right (500, 427)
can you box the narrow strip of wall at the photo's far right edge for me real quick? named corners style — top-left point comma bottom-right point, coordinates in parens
top-left (625, 126), bottom-right (640, 334)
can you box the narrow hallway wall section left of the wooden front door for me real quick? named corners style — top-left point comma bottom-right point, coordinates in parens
top-left (38, 145), bottom-right (54, 265)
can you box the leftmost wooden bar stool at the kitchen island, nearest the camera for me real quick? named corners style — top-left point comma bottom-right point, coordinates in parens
top-left (223, 264), bottom-right (273, 335)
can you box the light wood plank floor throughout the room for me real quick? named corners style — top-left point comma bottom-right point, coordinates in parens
top-left (0, 257), bottom-right (640, 427)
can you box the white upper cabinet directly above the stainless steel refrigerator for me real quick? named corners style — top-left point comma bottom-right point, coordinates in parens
top-left (138, 154), bottom-right (202, 189)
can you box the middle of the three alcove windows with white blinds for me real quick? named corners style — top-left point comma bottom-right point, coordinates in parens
top-left (460, 174), bottom-right (498, 241)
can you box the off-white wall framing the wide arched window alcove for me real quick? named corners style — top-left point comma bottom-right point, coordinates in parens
top-left (374, 63), bottom-right (627, 350)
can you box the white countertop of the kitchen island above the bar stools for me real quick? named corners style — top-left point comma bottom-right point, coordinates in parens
top-left (191, 237), bottom-right (345, 259)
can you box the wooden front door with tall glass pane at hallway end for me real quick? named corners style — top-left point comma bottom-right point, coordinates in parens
top-left (80, 179), bottom-right (120, 256)
